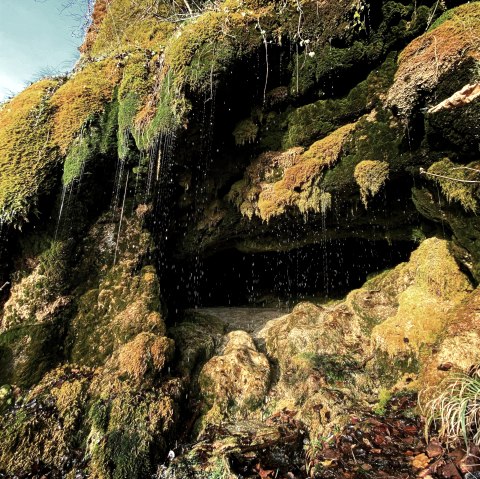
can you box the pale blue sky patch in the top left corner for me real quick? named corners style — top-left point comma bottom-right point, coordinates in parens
top-left (0, 0), bottom-right (87, 101)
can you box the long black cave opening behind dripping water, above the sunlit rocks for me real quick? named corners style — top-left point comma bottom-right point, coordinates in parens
top-left (162, 239), bottom-right (416, 310)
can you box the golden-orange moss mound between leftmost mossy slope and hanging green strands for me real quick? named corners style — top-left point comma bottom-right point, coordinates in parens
top-left (51, 59), bottom-right (121, 154)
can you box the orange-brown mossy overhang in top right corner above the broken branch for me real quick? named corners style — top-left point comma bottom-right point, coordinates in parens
top-left (389, 2), bottom-right (480, 115)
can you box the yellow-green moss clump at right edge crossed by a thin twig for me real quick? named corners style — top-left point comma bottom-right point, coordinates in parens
top-left (428, 158), bottom-right (479, 212)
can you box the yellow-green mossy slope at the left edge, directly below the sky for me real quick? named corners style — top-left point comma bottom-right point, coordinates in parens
top-left (0, 80), bottom-right (58, 222)
